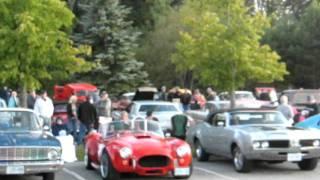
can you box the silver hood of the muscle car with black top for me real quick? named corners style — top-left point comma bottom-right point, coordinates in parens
top-left (235, 125), bottom-right (320, 140)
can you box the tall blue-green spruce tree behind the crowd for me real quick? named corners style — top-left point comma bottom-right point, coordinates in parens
top-left (74, 0), bottom-right (147, 92)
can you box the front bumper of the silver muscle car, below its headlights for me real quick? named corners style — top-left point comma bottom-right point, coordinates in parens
top-left (245, 147), bottom-right (320, 161)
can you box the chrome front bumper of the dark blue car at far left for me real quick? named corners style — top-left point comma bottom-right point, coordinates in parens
top-left (0, 160), bottom-right (64, 175)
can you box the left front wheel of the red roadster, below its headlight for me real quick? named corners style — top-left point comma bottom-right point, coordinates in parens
top-left (100, 151), bottom-right (120, 180)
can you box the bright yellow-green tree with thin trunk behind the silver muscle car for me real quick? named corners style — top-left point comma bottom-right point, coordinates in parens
top-left (173, 0), bottom-right (287, 106)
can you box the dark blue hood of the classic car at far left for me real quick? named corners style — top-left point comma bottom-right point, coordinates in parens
top-left (0, 132), bottom-right (60, 146)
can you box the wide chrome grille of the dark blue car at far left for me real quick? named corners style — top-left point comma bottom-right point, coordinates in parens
top-left (0, 147), bottom-right (50, 161)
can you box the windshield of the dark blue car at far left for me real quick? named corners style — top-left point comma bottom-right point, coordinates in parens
top-left (0, 111), bottom-right (41, 132)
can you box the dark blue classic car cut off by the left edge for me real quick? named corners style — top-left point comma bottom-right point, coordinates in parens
top-left (0, 108), bottom-right (64, 180)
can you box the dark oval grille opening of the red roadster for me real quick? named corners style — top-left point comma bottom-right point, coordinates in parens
top-left (139, 156), bottom-right (170, 168)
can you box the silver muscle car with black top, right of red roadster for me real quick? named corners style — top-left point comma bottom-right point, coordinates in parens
top-left (187, 109), bottom-right (320, 172)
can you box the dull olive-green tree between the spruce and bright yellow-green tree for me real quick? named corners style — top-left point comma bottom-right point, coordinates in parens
top-left (137, 11), bottom-right (190, 87)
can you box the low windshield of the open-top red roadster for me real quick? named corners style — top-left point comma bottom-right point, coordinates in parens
top-left (105, 120), bottom-right (164, 137)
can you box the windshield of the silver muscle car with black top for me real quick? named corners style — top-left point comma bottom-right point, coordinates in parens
top-left (230, 112), bottom-right (287, 125)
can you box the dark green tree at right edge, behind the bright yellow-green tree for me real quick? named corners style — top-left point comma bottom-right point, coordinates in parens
top-left (263, 1), bottom-right (320, 88)
